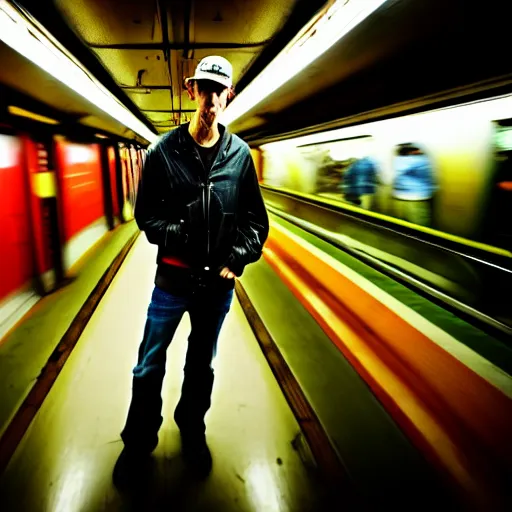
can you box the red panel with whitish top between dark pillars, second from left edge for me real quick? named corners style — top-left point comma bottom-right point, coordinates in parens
top-left (56, 141), bottom-right (105, 241)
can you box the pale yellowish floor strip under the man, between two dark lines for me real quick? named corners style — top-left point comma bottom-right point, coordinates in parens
top-left (0, 236), bottom-right (324, 512)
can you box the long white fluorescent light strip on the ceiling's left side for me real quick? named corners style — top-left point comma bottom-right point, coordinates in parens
top-left (0, 0), bottom-right (158, 142)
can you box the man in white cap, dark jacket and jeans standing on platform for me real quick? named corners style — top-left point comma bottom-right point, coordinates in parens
top-left (114, 56), bottom-right (268, 481)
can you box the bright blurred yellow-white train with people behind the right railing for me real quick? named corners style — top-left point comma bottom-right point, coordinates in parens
top-left (259, 95), bottom-right (512, 255)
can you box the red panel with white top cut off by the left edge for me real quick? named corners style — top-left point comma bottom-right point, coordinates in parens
top-left (0, 134), bottom-right (33, 299)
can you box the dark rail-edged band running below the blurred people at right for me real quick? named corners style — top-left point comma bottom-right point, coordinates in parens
top-left (262, 186), bottom-right (512, 344)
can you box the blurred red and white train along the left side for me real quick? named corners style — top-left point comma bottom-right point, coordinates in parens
top-left (0, 112), bottom-right (145, 331)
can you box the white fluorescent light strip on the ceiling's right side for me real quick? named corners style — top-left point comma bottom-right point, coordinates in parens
top-left (222, 0), bottom-right (387, 125)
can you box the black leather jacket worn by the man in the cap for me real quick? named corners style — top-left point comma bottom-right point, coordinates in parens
top-left (135, 123), bottom-right (269, 276)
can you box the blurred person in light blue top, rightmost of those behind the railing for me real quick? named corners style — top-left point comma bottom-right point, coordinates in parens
top-left (392, 143), bottom-right (437, 226)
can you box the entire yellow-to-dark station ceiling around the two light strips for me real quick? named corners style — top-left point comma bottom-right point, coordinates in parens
top-left (0, 0), bottom-right (512, 142)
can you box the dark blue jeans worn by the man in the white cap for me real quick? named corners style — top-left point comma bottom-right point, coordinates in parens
top-left (121, 286), bottom-right (233, 452)
